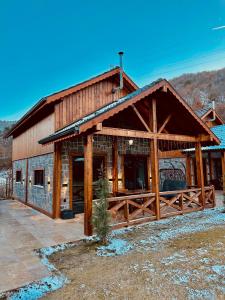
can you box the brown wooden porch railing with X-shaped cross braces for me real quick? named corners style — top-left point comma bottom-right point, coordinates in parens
top-left (94, 186), bottom-right (215, 228)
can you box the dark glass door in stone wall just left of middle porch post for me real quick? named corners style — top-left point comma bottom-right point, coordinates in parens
top-left (124, 155), bottom-right (148, 190)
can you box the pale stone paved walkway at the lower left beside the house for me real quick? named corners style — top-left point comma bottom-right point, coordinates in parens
top-left (0, 200), bottom-right (84, 293)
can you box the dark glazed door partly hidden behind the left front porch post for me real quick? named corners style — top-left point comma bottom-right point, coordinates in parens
top-left (72, 155), bottom-right (105, 214)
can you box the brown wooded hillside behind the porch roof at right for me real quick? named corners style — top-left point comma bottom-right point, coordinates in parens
top-left (170, 68), bottom-right (225, 120)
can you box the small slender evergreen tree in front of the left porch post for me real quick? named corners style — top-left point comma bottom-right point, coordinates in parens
top-left (92, 166), bottom-right (110, 244)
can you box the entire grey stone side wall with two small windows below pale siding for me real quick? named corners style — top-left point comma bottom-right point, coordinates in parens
top-left (13, 153), bottom-right (53, 214)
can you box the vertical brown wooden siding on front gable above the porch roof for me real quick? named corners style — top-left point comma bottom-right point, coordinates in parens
top-left (55, 79), bottom-right (131, 130)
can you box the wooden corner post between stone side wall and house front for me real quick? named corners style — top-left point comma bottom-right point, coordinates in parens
top-left (53, 143), bottom-right (62, 218)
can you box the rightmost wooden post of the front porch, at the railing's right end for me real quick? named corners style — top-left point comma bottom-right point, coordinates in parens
top-left (195, 142), bottom-right (205, 207)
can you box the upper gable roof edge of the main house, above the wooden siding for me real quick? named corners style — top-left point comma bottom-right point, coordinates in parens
top-left (5, 67), bottom-right (138, 138)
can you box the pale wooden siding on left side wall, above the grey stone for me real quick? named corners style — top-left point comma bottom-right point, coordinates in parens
top-left (12, 113), bottom-right (54, 161)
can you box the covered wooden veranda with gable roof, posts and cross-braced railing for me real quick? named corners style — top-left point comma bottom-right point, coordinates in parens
top-left (40, 80), bottom-right (219, 235)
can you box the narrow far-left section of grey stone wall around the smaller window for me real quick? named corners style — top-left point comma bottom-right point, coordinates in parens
top-left (13, 159), bottom-right (26, 202)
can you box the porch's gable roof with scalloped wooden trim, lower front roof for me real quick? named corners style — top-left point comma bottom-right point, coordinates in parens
top-left (39, 79), bottom-right (219, 144)
